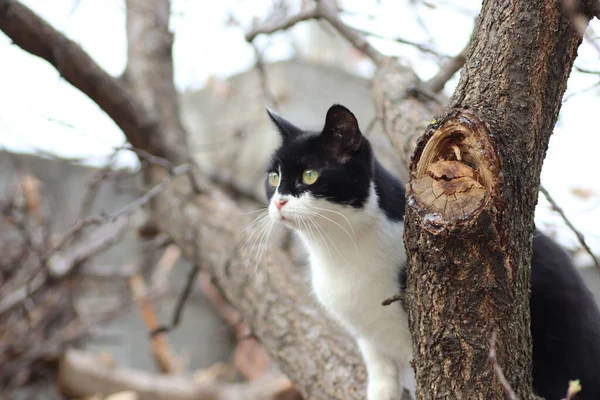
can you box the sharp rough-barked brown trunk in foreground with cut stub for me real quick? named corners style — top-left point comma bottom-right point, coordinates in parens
top-left (404, 0), bottom-right (591, 399)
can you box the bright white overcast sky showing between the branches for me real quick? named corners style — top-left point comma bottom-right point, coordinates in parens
top-left (0, 0), bottom-right (600, 262)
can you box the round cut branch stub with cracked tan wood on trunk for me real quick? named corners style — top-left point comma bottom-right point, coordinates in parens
top-left (408, 110), bottom-right (499, 234)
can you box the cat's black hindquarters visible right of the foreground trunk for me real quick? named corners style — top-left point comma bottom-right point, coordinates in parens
top-left (530, 232), bottom-right (600, 400)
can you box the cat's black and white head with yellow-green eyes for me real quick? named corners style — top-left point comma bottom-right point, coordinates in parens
top-left (265, 105), bottom-right (373, 230)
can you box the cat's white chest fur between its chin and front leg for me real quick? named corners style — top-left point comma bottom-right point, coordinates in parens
top-left (299, 189), bottom-right (411, 362)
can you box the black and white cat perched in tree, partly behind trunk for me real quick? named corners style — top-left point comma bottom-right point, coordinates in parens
top-left (265, 105), bottom-right (600, 400)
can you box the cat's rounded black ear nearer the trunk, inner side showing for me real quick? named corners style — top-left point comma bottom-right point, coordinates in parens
top-left (321, 104), bottom-right (362, 159)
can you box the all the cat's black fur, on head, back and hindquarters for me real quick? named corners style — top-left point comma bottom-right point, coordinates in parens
top-left (266, 105), bottom-right (600, 400)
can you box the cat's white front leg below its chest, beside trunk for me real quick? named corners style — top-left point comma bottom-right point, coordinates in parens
top-left (357, 338), bottom-right (401, 400)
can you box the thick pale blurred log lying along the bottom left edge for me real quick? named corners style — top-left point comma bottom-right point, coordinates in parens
top-left (59, 349), bottom-right (298, 400)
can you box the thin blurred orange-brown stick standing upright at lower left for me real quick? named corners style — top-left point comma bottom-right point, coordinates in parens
top-left (129, 274), bottom-right (181, 374)
